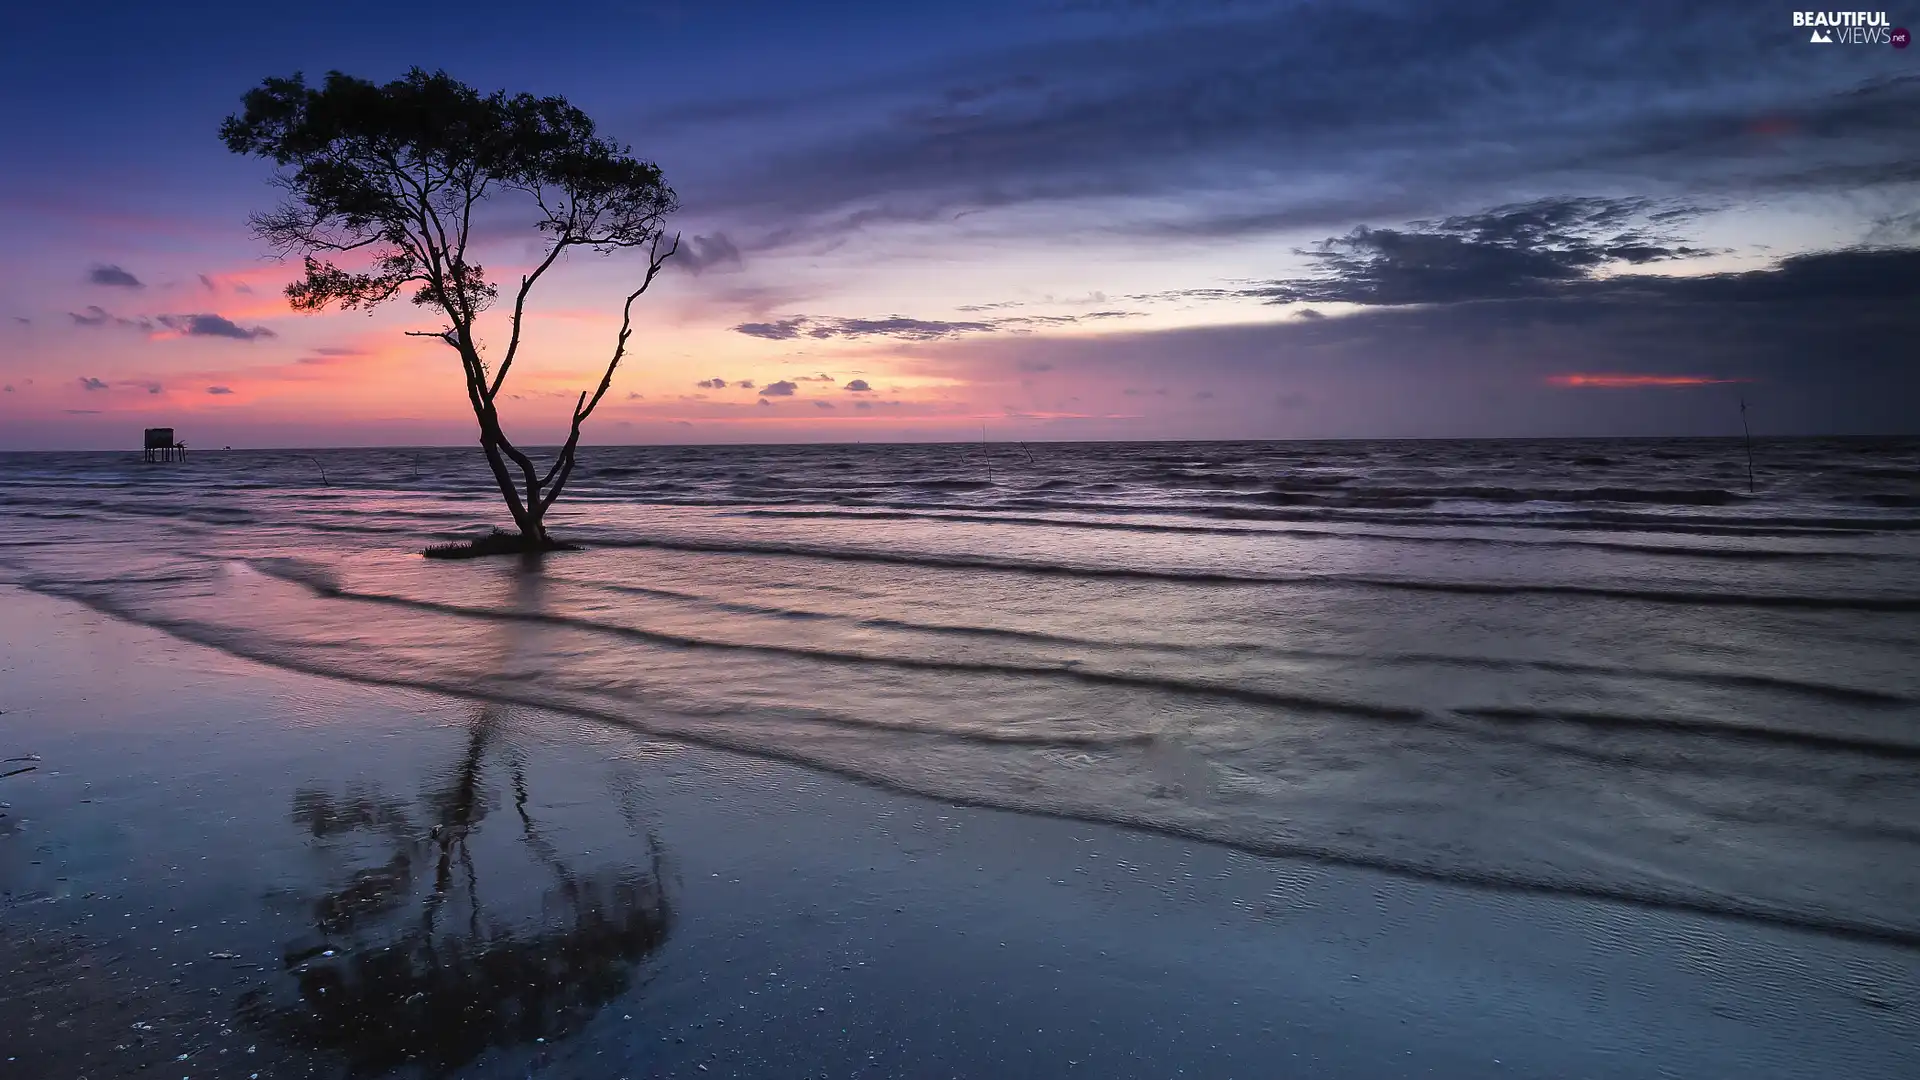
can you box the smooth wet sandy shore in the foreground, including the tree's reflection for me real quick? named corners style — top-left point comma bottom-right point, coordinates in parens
top-left (0, 586), bottom-right (1920, 1080)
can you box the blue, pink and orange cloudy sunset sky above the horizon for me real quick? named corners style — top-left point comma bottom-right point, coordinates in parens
top-left (0, 0), bottom-right (1920, 450)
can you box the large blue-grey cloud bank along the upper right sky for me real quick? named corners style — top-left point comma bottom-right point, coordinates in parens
top-left (679, 0), bottom-right (1920, 244)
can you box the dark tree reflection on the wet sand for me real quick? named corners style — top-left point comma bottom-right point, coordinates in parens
top-left (238, 707), bottom-right (672, 1074)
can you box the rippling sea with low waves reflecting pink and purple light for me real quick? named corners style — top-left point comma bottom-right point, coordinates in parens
top-left (0, 438), bottom-right (1920, 945)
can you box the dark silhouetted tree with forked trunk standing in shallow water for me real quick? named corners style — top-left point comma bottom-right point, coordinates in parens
top-left (221, 69), bottom-right (680, 550)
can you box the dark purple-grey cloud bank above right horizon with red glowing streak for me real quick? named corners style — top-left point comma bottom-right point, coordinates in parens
top-left (925, 248), bottom-right (1920, 436)
